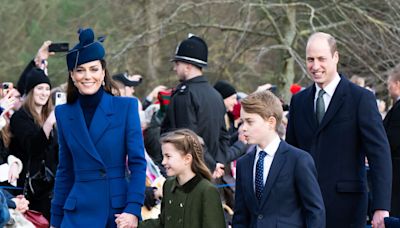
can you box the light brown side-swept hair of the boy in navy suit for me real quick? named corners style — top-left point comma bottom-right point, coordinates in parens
top-left (241, 91), bottom-right (283, 130)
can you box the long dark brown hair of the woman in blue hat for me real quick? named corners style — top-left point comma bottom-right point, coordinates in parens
top-left (67, 59), bottom-right (119, 104)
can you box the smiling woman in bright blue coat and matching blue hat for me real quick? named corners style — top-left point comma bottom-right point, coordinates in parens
top-left (51, 29), bottom-right (146, 227)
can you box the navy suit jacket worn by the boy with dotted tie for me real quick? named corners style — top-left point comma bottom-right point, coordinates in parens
top-left (232, 141), bottom-right (325, 228)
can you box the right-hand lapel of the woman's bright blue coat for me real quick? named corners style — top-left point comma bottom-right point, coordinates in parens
top-left (89, 93), bottom-right (114, 145)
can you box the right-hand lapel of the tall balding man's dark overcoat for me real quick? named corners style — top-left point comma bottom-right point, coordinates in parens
top-left (317, 76), bottom-right (349, 133)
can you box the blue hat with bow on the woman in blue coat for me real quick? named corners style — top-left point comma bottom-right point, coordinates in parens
top-left (67, 28), bottom-right (105, 71)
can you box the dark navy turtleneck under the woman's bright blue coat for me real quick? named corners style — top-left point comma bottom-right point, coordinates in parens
top-left (78, 86), bottom-right (104, 129)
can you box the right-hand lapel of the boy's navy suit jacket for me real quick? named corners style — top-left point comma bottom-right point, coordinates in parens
top-left (260, 141), bottom-right (287, 207)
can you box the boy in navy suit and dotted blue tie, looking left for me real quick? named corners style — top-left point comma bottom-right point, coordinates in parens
top-left (233, 91), bottom-right (325, 228)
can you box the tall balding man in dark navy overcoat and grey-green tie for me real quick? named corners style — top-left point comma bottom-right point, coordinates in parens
top-left (286, 33), bottom-right (392, 228)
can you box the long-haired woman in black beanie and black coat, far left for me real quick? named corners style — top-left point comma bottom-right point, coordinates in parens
top-left (9, 68), bottom-right (58, 219)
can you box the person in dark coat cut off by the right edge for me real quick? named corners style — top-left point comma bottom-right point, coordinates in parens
top-left (383, 65), bottom-right (400, 217)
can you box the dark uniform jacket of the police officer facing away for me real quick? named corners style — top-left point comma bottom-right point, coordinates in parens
top-left (161, 76), bottom-right (229, 170)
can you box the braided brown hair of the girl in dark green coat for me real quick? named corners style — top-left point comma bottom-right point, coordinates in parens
top-left (160, 129), bottom-right (211, 180)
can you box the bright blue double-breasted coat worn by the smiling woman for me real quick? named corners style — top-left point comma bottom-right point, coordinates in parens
top-left (51, 93), bottom-right (146, 227)
